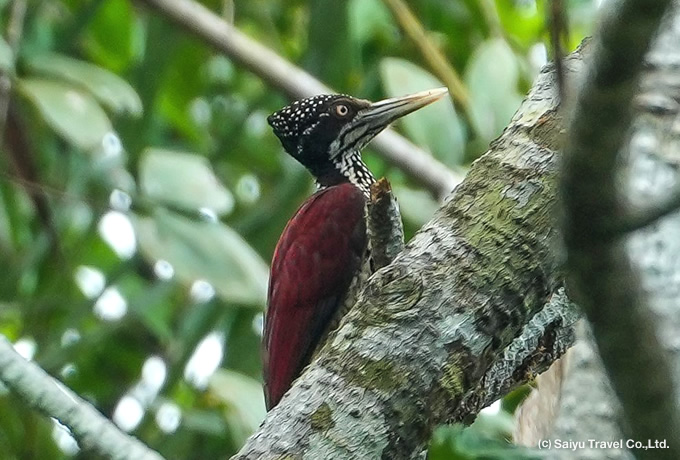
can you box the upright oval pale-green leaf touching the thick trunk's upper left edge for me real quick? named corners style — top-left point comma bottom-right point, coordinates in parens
top-left (465, 39), bottom-right (522, 144)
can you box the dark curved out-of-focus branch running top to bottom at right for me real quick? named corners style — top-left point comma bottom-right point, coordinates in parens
top-left (560, 0), bottom-right (680, 459)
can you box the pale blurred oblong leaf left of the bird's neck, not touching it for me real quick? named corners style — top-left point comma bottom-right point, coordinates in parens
top-left (139, 148), bottom-right (234, 214)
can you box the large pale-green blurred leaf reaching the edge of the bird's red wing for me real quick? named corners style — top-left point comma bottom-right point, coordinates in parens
top-left (132, 208), bottom-right (268, 308)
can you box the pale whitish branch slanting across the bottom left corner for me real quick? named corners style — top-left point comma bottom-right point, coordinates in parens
top-left (0, 335), bottom-right (163, 460)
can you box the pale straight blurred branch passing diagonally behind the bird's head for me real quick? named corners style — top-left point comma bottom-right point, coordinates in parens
top-left (139, 0), bottom-right (462, 198)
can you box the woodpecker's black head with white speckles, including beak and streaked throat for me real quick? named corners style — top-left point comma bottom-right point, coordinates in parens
top-left (267, 88), bottom-right (447, 192)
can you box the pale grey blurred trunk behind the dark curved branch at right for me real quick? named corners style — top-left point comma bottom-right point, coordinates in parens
top-left (550, 2), bottom-right (680, 459)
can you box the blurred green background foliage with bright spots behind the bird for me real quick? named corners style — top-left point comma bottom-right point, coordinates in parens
top-left (0, 0), bottom-right (595, 459)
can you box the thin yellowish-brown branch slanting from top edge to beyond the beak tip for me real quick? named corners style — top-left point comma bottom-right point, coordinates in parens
top-left (383, 0), bottom-right (475, 129)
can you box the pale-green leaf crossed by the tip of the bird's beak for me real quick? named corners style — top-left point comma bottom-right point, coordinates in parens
top-left (380, 58), bottom-right (465, 165)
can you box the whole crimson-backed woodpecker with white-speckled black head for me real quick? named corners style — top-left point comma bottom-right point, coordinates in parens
top-left (262, 88), bottom-right (447, 411)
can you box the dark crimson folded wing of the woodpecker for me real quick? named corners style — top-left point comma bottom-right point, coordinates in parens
top-left (263, 184), bottom-right (366, 409)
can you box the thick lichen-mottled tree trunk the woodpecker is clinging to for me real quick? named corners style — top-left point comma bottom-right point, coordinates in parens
top-left (235, 43), bottom-right (580, 459)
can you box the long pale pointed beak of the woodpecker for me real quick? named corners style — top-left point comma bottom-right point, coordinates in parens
top-left (355, 88), bottom-right (448, 129)
